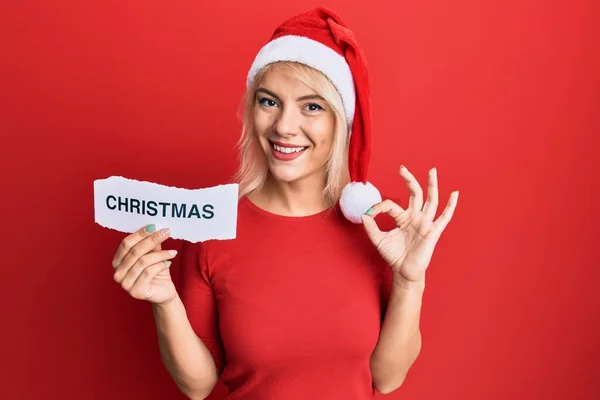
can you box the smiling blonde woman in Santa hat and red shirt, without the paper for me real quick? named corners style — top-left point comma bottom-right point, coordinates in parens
top-left (113, 8), bottom-right (458, 400)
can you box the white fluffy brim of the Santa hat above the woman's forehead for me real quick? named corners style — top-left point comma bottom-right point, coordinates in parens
top-left (246, 35), bottom-right (356, 126)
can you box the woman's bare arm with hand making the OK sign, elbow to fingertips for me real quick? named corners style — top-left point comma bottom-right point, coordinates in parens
top-left (362, 166), bottom-right (458, 393)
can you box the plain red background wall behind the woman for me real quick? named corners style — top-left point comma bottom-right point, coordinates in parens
top-left (0, 0), bottom-right (600, 400)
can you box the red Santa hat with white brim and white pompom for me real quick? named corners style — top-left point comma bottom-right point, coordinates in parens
top-left (246, 8), bottom-right (381, 224)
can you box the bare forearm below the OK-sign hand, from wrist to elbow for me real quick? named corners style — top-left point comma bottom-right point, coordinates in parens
top-left (371, 276), bottom-right (425, 394)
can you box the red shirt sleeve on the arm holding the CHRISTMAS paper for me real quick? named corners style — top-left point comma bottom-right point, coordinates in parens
top-left (179, 242), bottom-right (225, 376)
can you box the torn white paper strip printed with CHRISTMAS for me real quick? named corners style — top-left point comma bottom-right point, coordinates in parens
top-left (94, 176), bottom-right (238, 242)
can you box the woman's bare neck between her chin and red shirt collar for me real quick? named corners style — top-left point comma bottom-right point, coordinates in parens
top-left (250, 174), bottom-right (328, 217)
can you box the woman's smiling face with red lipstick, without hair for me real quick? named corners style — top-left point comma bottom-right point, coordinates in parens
top-left (254, 65), bottom-right (335, 183)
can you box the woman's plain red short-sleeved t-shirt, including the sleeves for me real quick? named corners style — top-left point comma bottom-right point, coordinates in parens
top-left (180, 198), bottom-right (391, 400)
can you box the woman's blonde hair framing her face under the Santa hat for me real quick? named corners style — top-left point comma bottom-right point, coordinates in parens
top-left (234, 61), bottom-right (350, 207)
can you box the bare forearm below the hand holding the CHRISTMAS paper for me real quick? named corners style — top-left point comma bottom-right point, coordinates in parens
top-left (153, 296), bottom-right (218, 400)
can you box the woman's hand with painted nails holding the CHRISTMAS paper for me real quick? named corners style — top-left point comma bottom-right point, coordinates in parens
top-left (112, 225), bottom-right (177, 304)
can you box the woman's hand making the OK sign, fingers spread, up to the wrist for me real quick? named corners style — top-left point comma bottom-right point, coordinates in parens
top-left (362, 166), bottom-right (458, 284)
